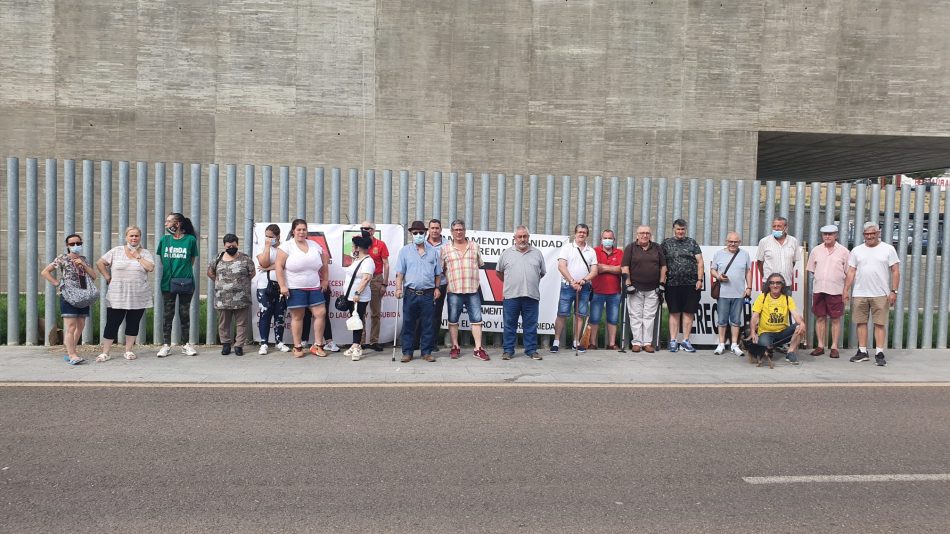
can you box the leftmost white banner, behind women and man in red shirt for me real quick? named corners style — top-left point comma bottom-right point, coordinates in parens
top-left (251, 222), bottom-right (405, 344)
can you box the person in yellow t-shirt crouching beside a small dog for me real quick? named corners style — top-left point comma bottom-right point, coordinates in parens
top-left (749, 273), bottom-right (805, 365)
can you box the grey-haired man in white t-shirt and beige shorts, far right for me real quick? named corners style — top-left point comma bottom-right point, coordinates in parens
top-left (842, 222), bottom-right (900, 367)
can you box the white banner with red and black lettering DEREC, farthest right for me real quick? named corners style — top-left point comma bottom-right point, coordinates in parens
top-left (689, 246), bottom-right (806, 345)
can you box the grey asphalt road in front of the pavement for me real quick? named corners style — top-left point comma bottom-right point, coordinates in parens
top-left (0, 386), bottom-right (950, 533)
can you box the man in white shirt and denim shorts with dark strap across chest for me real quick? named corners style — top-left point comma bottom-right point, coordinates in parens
top-left (551, 223), bottom-right (597, 352)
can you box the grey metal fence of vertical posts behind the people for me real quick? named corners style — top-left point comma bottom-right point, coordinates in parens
top-left (0, 157), bottom-right (950, 348)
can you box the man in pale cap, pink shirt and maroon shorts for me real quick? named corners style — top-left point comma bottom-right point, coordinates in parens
top-left (805, 224), bottom-right (850, 358)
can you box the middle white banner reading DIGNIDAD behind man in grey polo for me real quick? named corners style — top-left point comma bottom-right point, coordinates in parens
top-left (442, 230), bottom-right (567, 334)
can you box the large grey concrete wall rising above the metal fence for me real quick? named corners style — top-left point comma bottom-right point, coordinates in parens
top-left (0, 0), bottom-right (950, 178)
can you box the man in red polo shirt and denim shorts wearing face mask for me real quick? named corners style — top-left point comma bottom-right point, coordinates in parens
top-left (588, 230), bottom-right (623, 350)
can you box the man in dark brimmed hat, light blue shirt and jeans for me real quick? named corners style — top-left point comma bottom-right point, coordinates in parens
top-left (396, 221), bottom-right (442, 363)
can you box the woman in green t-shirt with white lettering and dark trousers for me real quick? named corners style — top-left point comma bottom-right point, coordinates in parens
top-left (157, 213), bottom-right (198, 358)
